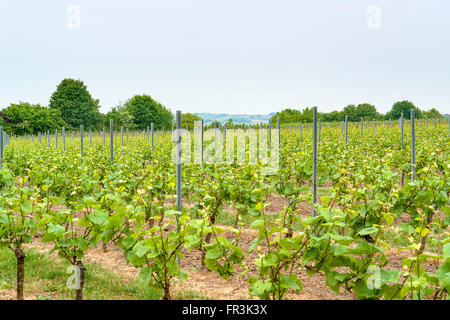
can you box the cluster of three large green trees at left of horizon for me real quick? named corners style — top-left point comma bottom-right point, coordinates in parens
top-left (0, 79), bottom-right (179, 135)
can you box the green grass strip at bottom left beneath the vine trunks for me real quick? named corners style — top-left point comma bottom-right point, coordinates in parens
top-left (0, 248), bottom-right (206, 300)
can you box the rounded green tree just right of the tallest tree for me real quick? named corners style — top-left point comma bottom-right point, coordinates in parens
top-left (124, 94), bottom-right (174, 130)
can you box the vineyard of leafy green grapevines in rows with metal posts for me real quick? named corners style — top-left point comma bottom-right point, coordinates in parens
top-left (0, 115), bottom-right (450, 300)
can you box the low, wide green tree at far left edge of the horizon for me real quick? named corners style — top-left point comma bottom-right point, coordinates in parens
top-left (2, 102), bottom-right (67, 135)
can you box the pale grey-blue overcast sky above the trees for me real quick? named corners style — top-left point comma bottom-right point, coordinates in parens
top-left (0, 0), bottom-right (450, 114)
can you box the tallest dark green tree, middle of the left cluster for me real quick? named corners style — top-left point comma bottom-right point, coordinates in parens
top-left (49, 79), bottom-right (102, 129)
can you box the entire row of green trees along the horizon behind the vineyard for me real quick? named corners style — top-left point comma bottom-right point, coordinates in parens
top-left (0, 79), bottom-right (442, 135)
